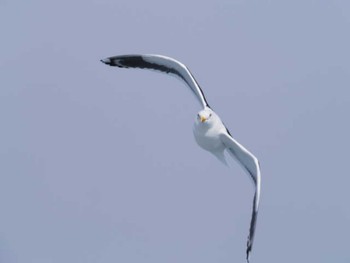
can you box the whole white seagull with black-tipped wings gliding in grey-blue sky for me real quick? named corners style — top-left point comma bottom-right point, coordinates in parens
top-left (101, 55), bottom-right (261, 263)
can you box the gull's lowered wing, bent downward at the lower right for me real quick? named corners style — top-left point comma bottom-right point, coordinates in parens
top-left (220, 132), bottom-right (261, 262)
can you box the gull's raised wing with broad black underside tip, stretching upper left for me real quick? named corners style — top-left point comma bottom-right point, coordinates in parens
top-left (101, 55), bottom-right (209, 108)
